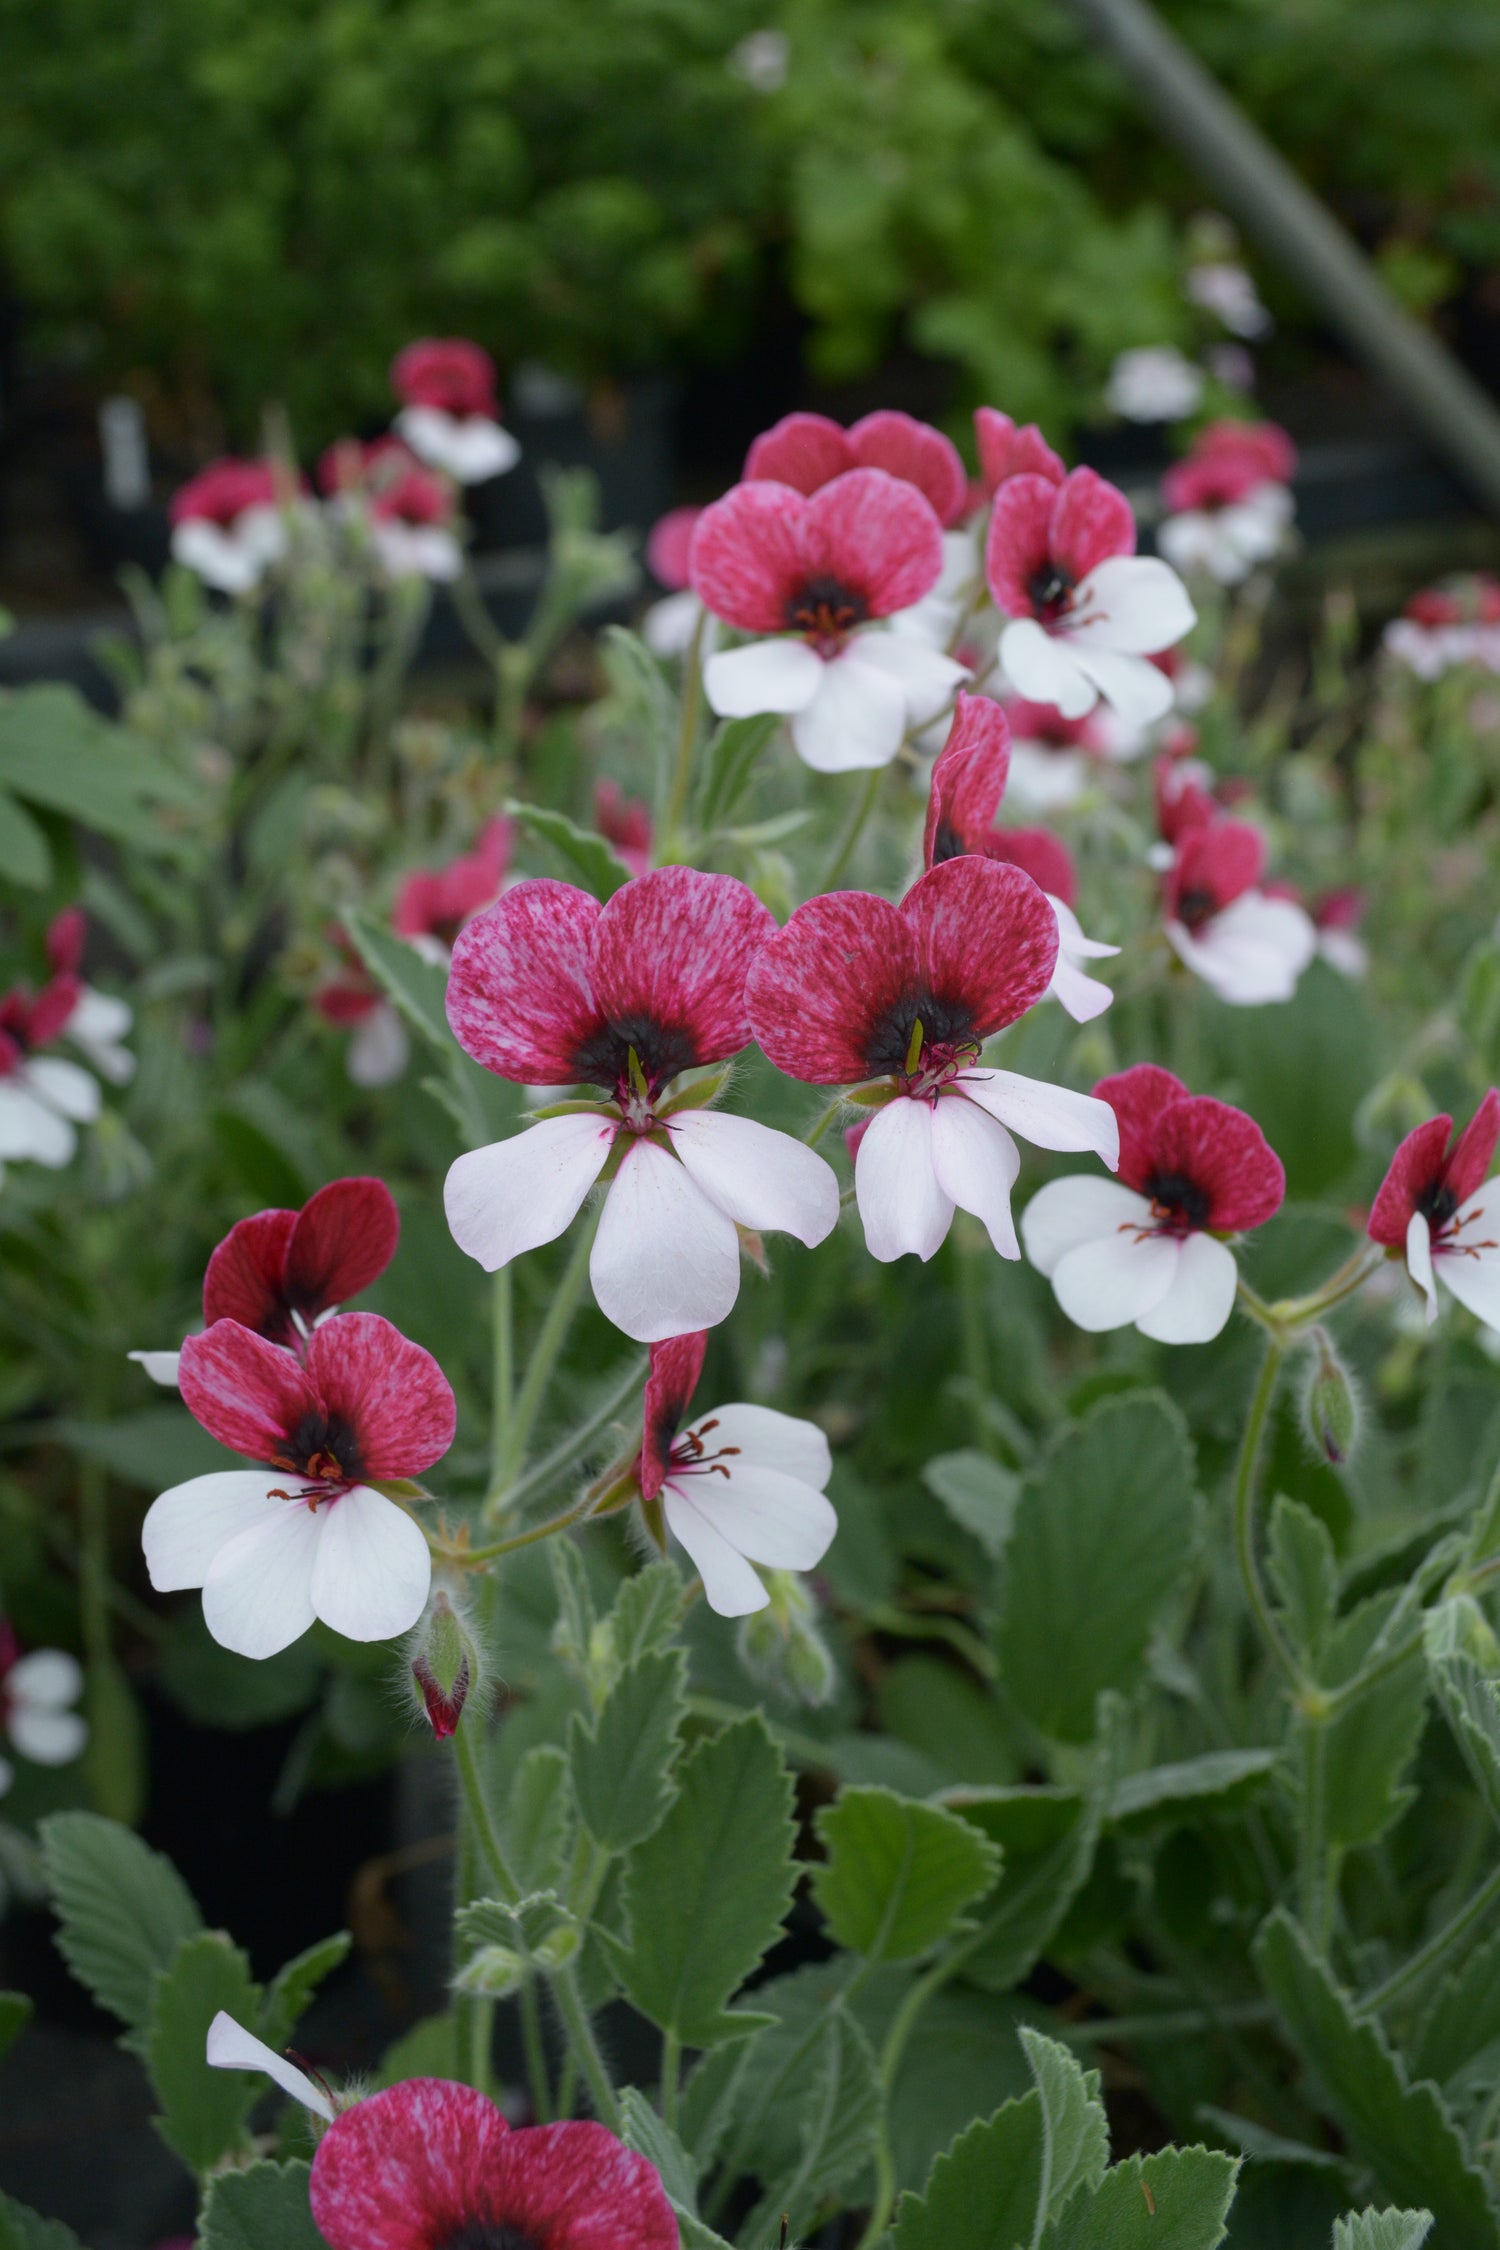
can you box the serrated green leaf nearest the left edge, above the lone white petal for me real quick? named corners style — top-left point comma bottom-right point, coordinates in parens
top-left (40, 1814), bottom-right (202, 2032)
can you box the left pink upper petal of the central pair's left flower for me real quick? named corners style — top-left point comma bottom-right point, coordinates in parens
top-left (448, 875), bottom-right (603, 1087)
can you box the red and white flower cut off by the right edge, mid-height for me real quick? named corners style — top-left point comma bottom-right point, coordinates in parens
top-left (1370, 1087), bottom-right (1500, 1328)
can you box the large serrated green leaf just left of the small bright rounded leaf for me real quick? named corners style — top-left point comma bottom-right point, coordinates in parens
top-left (618, 1715), bottom-right (796, 2048)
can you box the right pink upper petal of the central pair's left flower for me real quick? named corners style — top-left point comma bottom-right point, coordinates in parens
top-left (591, 866), bottom-right (776, 1085)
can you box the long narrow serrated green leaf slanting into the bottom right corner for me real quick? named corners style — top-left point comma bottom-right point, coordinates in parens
top-left (1255, 1910), bottom-right (1500, 2250)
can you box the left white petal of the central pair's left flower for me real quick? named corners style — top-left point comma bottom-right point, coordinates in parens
top-left (443, 1114), bottom-right (616, 1274)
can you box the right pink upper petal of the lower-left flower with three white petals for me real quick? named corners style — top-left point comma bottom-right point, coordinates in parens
top-left (299, 1312), bottom-right (457, 1481)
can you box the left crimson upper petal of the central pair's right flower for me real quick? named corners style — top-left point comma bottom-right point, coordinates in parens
top-left (744, 886), bottom-right (922, 1087)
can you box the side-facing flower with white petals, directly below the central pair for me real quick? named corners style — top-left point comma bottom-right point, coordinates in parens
top-left (634, 1334), bottom-right (839, 1618)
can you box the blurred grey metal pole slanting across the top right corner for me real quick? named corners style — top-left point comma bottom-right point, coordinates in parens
top-left (1066, 0), bottom-right (1500, 515)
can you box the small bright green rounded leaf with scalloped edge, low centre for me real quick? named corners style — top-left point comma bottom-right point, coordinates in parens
top-left (812, 1789), bottom-right (1001, 1962)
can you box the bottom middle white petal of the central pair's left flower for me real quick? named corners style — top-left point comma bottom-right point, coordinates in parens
top-left (589, 1141), bottom-right (740, 1343)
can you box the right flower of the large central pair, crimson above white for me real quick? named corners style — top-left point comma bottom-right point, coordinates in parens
top-left (744, 855), bottom-right (1118, 1260)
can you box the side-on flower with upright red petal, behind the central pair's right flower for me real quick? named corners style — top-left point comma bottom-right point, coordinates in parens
top-left (922, 695), bottom-right (1120, 1024)
